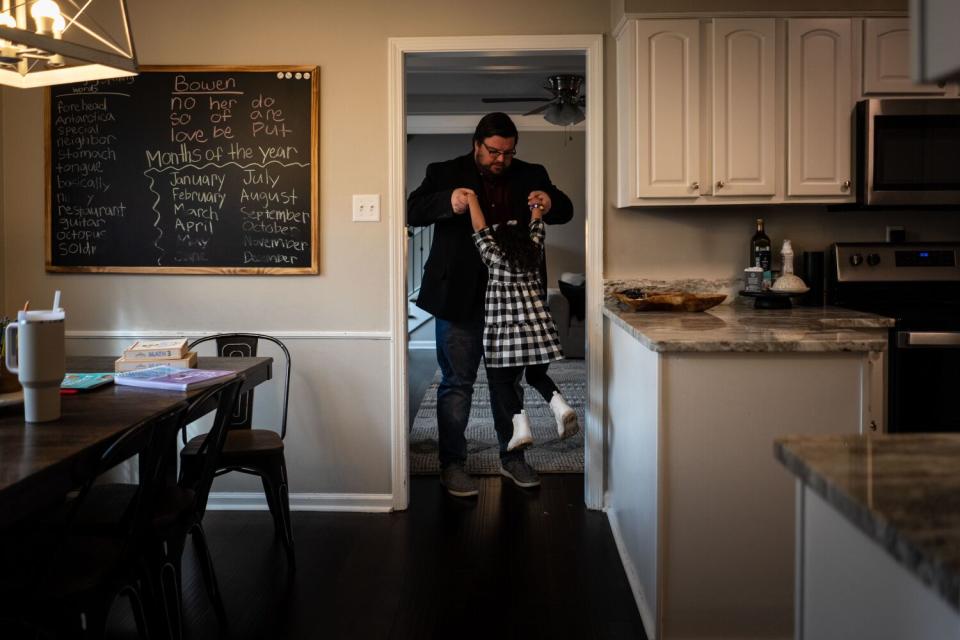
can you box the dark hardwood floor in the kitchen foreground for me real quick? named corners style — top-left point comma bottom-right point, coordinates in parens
top-left (97, 474), bottom-right (646, 640)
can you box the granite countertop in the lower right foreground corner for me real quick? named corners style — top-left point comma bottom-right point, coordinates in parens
top-left (774, 434), bottom-right (960, 611)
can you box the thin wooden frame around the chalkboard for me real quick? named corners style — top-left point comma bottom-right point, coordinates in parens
top-left (44, 65), bottom-right (320, 275)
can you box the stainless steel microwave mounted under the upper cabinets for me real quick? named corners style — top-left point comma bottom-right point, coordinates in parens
top-left (855, 98), bottom-right (960, 205)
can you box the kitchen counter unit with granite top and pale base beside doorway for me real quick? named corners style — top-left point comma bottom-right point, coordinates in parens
top-left (604, 302), bottom-right (892, 639)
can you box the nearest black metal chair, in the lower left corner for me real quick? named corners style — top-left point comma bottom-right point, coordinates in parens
top-left (0, 402), bottom-right (187, 638)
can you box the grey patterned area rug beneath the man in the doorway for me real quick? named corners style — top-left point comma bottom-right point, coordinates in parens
top-left (410, 360), bottom-right (587, 475)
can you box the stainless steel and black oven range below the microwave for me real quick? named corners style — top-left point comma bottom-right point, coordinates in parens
top-left (828, 243), bottom-right (960, 433)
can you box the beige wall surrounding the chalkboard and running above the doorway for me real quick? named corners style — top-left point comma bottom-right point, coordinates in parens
top-left (2, 0), bottom-right (610, 494)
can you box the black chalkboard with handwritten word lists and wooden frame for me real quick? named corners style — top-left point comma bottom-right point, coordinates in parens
top-left (46, 66), bottom-right (319, 274)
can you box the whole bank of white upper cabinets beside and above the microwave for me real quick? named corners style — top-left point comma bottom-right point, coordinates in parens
top-left (617, 15), bottom-right (944, 207)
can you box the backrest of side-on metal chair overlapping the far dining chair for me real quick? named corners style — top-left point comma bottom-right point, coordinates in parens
top-left (180, 374), bottom-right (244, 516)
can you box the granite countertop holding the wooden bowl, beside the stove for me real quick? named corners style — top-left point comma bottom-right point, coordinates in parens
top-left (604, 300), bottom-right (894, 353)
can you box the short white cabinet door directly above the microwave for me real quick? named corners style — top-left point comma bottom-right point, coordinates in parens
top-left (863, 18), bottom-right (944, 96)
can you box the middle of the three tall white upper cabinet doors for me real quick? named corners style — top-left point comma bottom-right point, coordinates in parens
top-left (713, 18), bottom-right (776, 197)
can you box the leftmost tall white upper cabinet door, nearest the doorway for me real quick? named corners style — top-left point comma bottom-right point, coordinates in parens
top-left (621, 20), bottom-right (700, 198)
